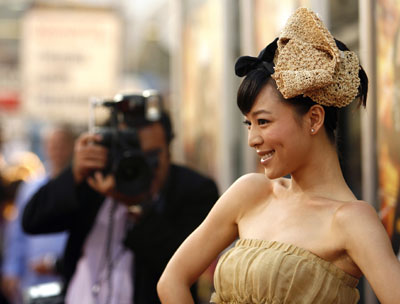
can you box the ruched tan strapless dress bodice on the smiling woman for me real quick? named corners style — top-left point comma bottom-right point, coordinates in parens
top-left (211, 239), bottom-right (359, 304)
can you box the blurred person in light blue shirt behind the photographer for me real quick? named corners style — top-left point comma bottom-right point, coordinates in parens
top-left (1, 125), bottom-right (74, 303)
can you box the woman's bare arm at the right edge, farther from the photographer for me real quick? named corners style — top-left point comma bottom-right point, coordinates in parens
top-left (335, 202), bottom-right (400, 304)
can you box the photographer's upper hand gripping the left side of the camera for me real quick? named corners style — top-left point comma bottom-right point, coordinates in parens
top-left (72, 133), bottom-right (107, 184)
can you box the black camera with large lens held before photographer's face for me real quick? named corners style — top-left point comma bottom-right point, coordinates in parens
top-left (89, 90), bottom-right (163, 197)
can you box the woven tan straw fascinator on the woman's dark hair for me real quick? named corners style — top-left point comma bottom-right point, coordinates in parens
top-left (272, 8), bottom-right (360, 108)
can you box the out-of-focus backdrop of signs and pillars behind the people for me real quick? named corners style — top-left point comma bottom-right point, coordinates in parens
top-left (0, 0), bottom-right (400, 303)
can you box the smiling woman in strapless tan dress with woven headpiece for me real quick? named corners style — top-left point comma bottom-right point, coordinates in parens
top-left (158, 8), bottom-right (400, 304)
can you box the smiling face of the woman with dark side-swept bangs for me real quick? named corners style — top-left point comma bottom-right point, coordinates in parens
top-left (245, 80), bottom-right (310, 179)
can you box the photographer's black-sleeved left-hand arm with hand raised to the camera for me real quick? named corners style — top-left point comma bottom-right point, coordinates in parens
top-left (22, 134), bottom-right (106, 234)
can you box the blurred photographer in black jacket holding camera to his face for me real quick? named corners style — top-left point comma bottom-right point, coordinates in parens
top-left (23, 94), bottom-right (218, 304)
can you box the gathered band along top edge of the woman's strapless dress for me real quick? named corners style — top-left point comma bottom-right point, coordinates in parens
top-left (235, 238), bottom-right (359, 288)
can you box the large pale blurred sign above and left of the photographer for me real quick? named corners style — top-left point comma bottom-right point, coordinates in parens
top-left (21, 7), bottom-right (121, 124)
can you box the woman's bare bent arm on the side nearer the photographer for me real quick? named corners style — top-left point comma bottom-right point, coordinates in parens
top-left (157, 176), bottom-right (266, 304)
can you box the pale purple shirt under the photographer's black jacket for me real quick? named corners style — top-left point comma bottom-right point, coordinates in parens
top-left (66, 198), bottom-right (133, 304)
